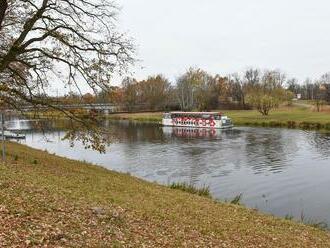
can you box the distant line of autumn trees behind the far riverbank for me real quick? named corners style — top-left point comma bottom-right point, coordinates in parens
top-left (51, 68), bottom-right (330, 115)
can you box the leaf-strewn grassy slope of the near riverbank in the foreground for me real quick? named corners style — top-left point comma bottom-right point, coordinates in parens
top-left (0, 144), bottom-right (330, 247)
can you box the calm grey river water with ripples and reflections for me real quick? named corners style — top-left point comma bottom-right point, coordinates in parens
top-left (14, 122), bottom-right (330, 227)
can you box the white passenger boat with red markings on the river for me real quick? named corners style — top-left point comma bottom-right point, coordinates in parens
top-left (162, 112), bottom-right (234, 129)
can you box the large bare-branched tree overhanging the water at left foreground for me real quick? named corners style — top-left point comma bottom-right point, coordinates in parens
top-left (0, 0), bottom-right (134, 151)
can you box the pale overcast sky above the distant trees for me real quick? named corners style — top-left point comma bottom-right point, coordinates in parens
top-left (118, 0), bottom-right (330, 84)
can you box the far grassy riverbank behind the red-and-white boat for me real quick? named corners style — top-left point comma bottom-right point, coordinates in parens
top-left (109, 106), bottom-right (330, 130)
